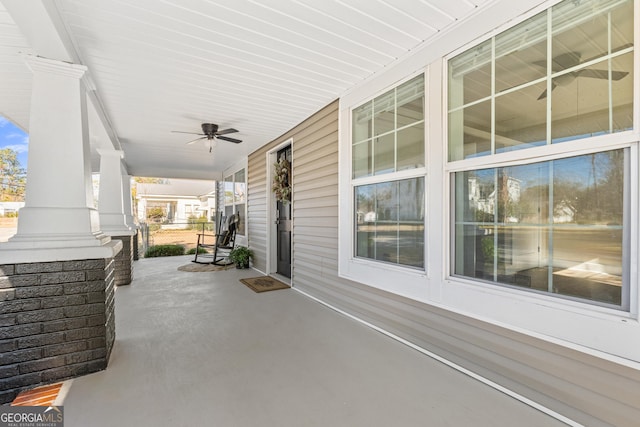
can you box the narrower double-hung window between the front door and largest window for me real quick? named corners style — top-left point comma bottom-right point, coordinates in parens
top-left (351, 75), bottom-right (425, 268)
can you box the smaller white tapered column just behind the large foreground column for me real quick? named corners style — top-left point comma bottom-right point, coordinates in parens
top-left (98, 149), bottom-right (134, 236)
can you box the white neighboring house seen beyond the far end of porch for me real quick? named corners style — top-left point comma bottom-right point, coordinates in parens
top-left (136, 179), bottom-right (216, 226)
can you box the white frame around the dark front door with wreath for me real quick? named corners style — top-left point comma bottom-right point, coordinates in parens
top-left (265, 138), bottom-right (293, 276)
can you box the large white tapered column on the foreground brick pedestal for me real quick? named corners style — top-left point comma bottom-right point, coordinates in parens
top-left (0, 56), bottom-right (122, 264)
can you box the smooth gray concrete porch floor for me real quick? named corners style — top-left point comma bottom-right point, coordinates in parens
top-left (64, 256), bottom-right (565, 427)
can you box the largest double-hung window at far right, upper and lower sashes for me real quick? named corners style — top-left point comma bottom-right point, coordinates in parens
top-left (448, 0), bottom-right (637, 309)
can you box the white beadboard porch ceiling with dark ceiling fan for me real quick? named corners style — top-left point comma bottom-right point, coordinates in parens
top-left (0, 0), bottom-right (495, 179)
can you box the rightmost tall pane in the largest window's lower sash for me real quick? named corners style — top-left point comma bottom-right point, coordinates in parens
top-left (552, 150), bottom-right (624, 305)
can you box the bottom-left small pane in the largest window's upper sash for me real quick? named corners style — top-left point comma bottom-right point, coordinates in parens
top-left (449, 101), bottom-right (491, 161)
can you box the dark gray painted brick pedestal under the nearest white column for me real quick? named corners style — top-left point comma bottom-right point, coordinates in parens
top-left (0, 258), bottom-right (115, 403)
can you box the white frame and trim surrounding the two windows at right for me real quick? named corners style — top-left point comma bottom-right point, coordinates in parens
top-left (338, 0), bottom-right (640, 366)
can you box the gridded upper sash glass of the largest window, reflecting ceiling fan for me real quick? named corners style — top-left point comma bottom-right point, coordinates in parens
top-left (448, 0), bottom-right (634, 161)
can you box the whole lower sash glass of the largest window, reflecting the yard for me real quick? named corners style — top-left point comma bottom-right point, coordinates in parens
top-left (453, 150), bottom-right (628, 306)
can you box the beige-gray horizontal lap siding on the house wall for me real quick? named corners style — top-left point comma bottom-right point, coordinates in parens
top-left (248, 102), bottom-right (640, 427)
